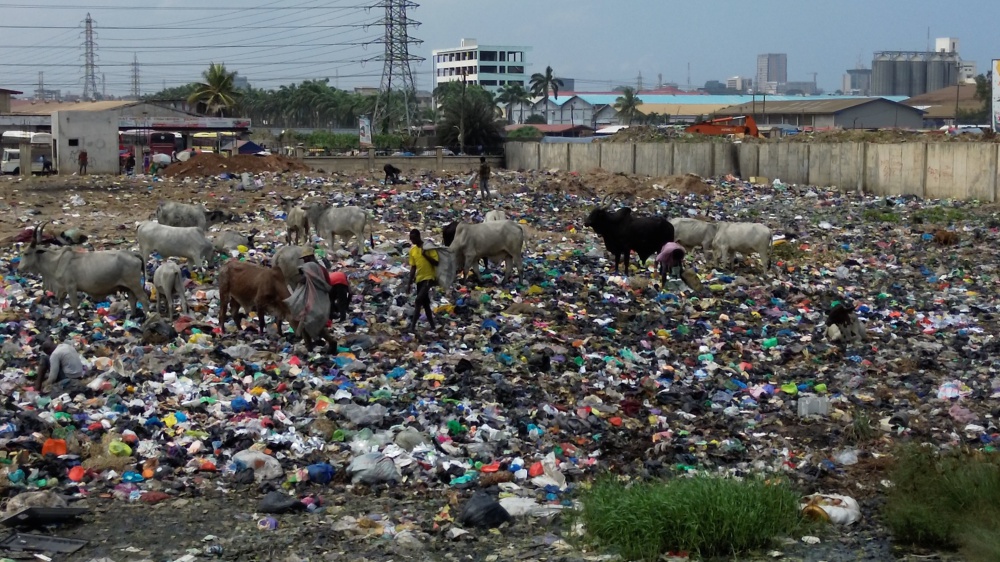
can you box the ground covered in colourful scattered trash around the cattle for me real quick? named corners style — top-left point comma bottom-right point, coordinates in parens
top-left (0, 167), bottom-right (1000, 560)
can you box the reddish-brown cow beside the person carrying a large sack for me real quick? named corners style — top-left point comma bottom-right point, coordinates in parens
top-left (219, 260), bottom-right (292, 333)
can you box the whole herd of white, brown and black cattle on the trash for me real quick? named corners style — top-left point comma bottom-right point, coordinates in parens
top-left (18, 196), bottom-right (771, 331)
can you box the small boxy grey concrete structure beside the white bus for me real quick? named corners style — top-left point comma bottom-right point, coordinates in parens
top-left (52, 107), bottom-right (120, 174)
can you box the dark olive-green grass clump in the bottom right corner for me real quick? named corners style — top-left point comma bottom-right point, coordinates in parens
top-left (885, 445), bottom-right (1000, 560)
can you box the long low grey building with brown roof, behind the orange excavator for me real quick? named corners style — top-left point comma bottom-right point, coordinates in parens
top-left (715, 98), bottom-right (924, 130)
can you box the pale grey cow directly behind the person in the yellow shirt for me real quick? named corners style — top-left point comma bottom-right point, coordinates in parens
top-left (448, 221), bottom-right (524, 283)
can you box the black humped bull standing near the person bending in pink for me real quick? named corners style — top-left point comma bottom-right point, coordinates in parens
top-left (583, 202), bottom-right (674, 274)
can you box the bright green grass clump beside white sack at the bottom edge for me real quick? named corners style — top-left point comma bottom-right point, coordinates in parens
top-left (579, 476), bottom-right (802, 560)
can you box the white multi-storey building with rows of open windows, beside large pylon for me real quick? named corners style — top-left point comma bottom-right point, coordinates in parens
top-left (432, 39), bottom-right (531, 92)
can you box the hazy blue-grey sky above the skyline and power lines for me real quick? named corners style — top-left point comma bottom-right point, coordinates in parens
top-left (0, 0), bottom-right (1000, 95)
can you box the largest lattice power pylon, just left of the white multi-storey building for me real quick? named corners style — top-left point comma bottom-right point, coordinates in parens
top-left (372, 0), bottom-right (424, 133)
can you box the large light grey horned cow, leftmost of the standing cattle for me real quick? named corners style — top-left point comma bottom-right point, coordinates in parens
top-left (18, 223), bottom-right (149, 314)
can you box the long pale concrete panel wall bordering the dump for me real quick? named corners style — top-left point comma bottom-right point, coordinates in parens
top-left (506, 142), bottom-right (1000, 201)
